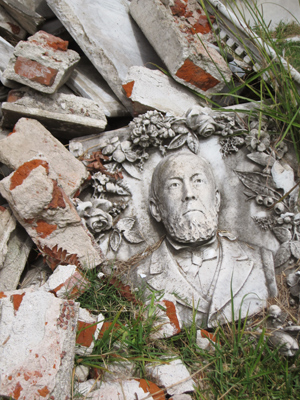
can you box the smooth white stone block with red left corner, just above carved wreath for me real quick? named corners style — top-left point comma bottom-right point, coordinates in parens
top-left (123, 66), bottom-right (203, 116)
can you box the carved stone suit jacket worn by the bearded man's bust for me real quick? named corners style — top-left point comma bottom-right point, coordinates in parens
top-left (137, 237), bottom-right (277, 327)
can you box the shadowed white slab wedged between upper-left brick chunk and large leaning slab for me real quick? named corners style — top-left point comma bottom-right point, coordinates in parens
top-left (66, 56), bottom-right (129, 118)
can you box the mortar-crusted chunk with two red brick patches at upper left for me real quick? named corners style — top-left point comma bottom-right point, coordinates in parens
top-left (3, 31), bottom-right (80, 94)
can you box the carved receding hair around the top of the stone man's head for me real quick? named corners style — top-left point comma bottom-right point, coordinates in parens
top-left (149, 151), bottom-right (216, 204)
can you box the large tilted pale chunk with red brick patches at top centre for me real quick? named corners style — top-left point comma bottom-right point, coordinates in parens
top-left (130, 0), bottom-right (231, 97)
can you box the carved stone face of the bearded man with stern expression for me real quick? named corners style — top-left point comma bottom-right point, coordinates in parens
top-left (152, 155), bottom-right (219, 244)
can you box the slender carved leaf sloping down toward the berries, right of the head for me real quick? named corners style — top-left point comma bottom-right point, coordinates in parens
top-left (235, 170), bottom-right (282, 200)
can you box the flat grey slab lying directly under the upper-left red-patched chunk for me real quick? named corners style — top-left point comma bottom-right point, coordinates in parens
top-left (2, 88), bottom-right (107, 139)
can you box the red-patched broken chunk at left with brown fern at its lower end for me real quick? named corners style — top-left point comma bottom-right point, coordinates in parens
top-left (0, 158), bottom-right (103, 270)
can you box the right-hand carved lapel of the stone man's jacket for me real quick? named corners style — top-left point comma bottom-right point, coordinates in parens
top-left (209, 239), bottom-right (254, 315)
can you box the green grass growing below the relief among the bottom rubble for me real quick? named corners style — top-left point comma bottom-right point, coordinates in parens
top-left (74, 271), bottom-right (300, 400)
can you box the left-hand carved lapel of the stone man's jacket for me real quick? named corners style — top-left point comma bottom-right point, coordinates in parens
top-left (148, 242), bottom-right (208, 313)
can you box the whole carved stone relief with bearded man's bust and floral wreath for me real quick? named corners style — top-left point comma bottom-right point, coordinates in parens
top-left (73, 106), bottom-right (300, 326)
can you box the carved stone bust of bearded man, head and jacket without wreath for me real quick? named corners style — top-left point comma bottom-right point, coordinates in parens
top-left (135, 152), bottom-right (277, 327)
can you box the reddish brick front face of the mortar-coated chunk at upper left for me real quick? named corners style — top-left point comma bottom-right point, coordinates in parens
top-left (15, 56), bottom-right (58, 86)
